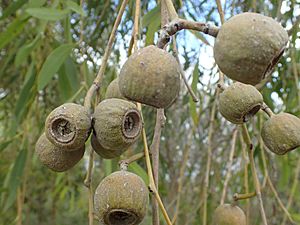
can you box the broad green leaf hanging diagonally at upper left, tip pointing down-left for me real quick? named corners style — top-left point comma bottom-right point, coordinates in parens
top-left (38, 44), bottom-right (74, 90)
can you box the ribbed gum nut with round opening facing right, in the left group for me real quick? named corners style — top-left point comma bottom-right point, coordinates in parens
top-left (94, 98), bottom-right (142, 152)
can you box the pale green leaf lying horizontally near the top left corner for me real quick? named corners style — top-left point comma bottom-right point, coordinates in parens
top-left (26, 7), bottom-right (70, 21)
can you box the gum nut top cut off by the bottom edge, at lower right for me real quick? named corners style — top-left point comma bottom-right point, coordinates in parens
top-left (214, 204), bottom-right (246, 225)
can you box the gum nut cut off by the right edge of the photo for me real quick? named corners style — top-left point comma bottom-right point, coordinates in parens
top-left (261, 113), bottom-right (300, 155)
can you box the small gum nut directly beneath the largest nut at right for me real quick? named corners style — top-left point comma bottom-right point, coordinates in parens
top-left (219, 82), bottom-right (263, 124)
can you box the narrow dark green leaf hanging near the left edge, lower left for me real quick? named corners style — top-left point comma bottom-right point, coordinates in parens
top-left (4, 149), bottom-right (27, 211)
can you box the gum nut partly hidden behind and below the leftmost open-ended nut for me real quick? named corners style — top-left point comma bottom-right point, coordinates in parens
top-left (35, 134), bottom-right (85, 172)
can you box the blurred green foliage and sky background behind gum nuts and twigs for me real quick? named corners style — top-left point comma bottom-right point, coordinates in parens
top-left (0, 0), bottom-right (300, 225)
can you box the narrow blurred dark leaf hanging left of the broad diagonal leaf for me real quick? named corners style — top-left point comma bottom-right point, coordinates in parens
top-left (15, 63), bottom-right (35, 121)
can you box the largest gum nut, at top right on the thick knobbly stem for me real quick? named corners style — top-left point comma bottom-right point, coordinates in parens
top-left (214, 13), bottom-right (288, 85)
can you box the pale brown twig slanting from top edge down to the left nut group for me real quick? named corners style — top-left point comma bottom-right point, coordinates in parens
top-left (84, 0), bottom-right (128, 110)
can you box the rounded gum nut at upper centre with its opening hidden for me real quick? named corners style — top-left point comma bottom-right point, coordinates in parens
top-left (119, 45), bottom-right (180, 108)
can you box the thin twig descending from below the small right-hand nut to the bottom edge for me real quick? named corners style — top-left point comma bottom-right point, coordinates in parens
top-left (242, 124), bottom-right (268, 225)
